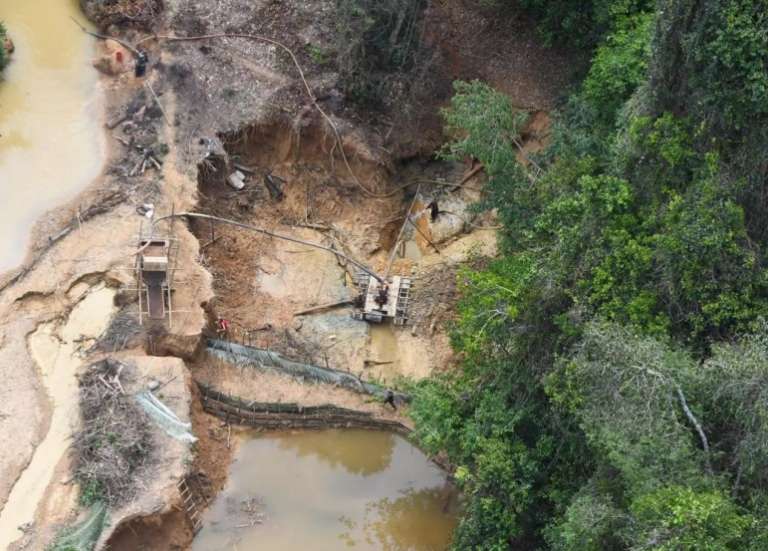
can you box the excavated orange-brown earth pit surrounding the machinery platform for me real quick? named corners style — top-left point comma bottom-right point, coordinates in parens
top-left (192, 115), bottom-right (495, 385)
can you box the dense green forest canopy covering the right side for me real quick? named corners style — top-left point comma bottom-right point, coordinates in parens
top-left (413, 0), bottom-right (768, 551)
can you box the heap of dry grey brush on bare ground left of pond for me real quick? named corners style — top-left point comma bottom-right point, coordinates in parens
top-left (74, 359), bottom-right (153, 506)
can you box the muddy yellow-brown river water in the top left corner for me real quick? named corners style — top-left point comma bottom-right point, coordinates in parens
top-left (0, 0), bottom-right (104, 271)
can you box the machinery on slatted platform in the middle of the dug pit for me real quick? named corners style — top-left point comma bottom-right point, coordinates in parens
top-left (352, 272), bottom-right (411, 325)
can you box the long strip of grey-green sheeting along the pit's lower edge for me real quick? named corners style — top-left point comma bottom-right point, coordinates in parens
top-left (208, 339), bottom-right (410, 402)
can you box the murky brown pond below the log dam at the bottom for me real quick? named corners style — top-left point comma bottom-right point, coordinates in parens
top-left (192, 430), bottom-right (457, 551)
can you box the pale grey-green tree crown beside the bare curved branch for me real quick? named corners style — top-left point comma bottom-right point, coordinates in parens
top-left (548, 323), bottom-right (704, 494)
